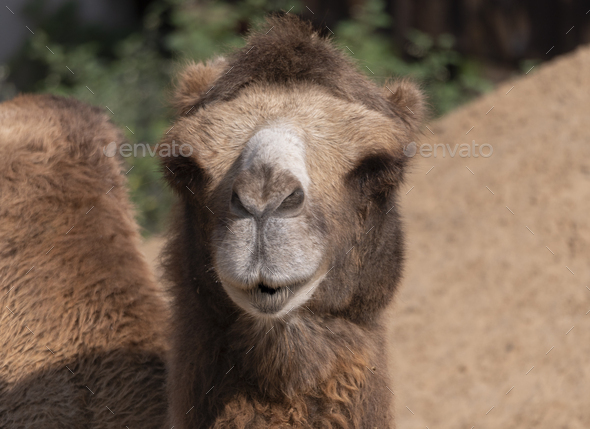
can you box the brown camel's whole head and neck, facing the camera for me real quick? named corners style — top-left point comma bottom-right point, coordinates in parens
top-left (161, 15), bottom-right (425, 429)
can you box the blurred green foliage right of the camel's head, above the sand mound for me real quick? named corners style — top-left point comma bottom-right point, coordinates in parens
top-left (334, 0), bottom-right (492, 116)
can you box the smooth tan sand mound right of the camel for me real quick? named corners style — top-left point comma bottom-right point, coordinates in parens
top-left (391, 41), bottom-right (590, 429)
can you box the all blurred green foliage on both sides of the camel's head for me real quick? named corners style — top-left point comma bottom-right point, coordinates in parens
top-left (0, 0), bottom-right (491, 234)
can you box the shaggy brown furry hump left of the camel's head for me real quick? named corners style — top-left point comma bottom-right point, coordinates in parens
top-left (0, 95), bottom-right (166, 429)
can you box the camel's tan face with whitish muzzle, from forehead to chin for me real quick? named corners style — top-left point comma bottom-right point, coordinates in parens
top-left (162, 84), bottom-right (416, 318)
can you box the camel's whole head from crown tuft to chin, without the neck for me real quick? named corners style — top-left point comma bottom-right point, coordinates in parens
top-left (162, 16), bottom-right (424, 319)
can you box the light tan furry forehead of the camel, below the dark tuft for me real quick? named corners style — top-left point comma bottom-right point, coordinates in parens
top-left (174, 85), bottom-right (407, 194)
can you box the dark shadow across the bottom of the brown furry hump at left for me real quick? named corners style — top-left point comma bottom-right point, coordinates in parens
top-left (0, 349), bottom-right (167, 429)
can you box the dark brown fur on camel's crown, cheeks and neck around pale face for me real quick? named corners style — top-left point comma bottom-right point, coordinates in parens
top-left (162, 16), bottom-right (423, 429)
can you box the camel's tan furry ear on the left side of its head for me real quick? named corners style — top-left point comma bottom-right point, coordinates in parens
top-left (172, 57), bottom-right (227, 115)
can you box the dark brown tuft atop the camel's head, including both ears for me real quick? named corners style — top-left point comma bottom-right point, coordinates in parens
top-left (173, 15), bottom-right (426, 134)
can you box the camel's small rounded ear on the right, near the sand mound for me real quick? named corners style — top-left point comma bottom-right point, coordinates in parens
top-left (383, 79), bottom-right (427, 134)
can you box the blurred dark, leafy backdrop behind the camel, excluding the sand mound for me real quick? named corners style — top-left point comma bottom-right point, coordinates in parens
top-left (0, 0), bottom-right (590, 235)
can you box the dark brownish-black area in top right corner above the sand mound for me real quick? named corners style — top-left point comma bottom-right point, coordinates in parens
top-left (387, 0), bottom-right (590, 67)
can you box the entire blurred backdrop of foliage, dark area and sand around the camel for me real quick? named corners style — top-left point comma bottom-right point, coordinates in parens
top-left (0, 0), bottom-right (590, 429)
